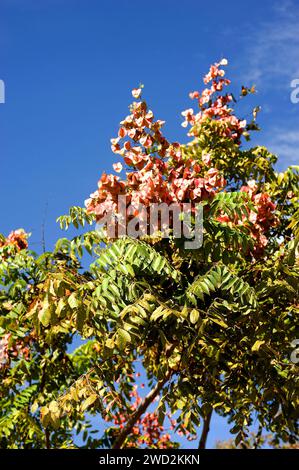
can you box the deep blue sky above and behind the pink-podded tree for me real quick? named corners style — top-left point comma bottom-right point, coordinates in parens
top-left (0, 0), bottom-right (299, 444)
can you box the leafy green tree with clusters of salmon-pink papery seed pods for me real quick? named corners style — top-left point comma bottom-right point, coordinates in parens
top-left (0, 59), bottom-right (299, 448)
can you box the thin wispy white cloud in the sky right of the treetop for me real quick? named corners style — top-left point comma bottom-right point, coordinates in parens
top-left (238, 0), bottom-right (299, 168)
